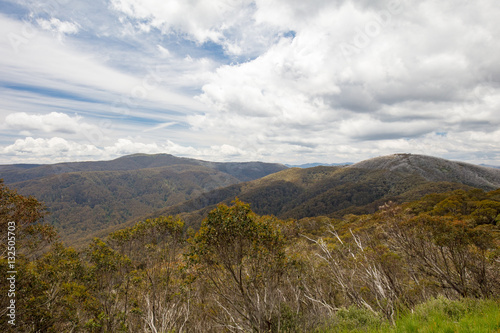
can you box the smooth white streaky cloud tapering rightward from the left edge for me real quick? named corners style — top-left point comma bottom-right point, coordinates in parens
top-left (0, 14), bottom-right (207, 112)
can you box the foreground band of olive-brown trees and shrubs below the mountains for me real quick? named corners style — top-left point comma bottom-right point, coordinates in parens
top-left (0, 176), bottom-right (500, 332)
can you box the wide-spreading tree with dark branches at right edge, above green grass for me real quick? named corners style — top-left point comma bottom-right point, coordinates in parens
top-left (385, 206), bottom-right (500, 297)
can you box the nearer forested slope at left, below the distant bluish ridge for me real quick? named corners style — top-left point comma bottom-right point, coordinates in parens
top-left (8, 165), bottom-right (238, 243)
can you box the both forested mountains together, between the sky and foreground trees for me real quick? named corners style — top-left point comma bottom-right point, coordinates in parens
top-left (0, 154), bottom-right (500, 244)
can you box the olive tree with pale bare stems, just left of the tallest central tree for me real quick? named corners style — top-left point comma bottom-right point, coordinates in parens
top-left (107, 216), bottom-right (188, 332)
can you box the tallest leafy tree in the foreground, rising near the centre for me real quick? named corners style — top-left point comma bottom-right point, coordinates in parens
top-left (188, 199), bottom-right (287, 332)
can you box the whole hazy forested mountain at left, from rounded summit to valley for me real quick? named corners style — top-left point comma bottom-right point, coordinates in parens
top-left (0, 154), bottom-right (286, 243)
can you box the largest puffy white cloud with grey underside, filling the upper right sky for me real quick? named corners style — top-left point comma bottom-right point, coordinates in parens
top-left (186, 1), bottom-right (500, 162)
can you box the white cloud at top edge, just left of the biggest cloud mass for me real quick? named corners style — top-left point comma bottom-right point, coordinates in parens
top-left (111, 0), bottom-right (286, 57)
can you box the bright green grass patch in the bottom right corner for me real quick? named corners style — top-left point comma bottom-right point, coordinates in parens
top-left (315, 297), bottom-right (500, 333)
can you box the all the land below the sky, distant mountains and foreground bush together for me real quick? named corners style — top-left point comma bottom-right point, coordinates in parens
top-left (0, 154), bottom-right (500, 333)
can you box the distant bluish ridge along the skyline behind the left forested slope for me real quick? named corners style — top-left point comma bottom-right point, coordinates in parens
top-left (0, 154), bottom-right (287, 184)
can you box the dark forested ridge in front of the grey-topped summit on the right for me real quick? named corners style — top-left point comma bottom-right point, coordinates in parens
top-left (157, 166), bottom-right (480, 232)
